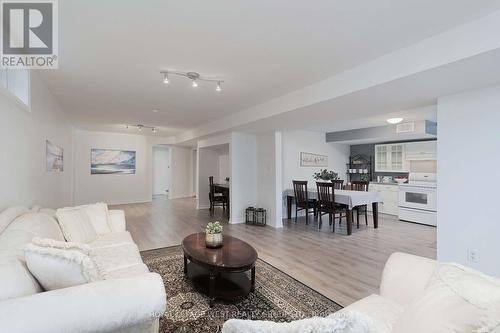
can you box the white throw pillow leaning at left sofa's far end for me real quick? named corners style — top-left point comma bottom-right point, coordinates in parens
top-left (56, 207), bottom-right (97, 243)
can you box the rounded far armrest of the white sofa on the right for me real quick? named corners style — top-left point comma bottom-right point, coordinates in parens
top-left (380, 252), bottom-right (437, 306)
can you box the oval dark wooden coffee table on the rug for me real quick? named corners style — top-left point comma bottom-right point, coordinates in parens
top-left (182, 232), bottom-right (258, 307)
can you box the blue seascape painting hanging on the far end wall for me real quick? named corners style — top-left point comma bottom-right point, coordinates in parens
top-left (90, 149), bottom-right (135, 175)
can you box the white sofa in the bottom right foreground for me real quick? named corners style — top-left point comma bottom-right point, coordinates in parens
top-left (223, 253), bottom-right (500, 333)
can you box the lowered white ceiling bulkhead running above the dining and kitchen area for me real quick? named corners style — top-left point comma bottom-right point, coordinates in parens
top-left (233, 49), bottom-right (500, 133)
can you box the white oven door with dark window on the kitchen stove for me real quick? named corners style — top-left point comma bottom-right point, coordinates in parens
top-left (399, 185), bottom-right (437, 212)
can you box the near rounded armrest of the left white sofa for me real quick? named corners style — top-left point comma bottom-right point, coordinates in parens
top-left (0, 273), bottom-right (166, 333)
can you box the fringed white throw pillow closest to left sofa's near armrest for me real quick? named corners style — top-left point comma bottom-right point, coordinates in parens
top-left (24, 244), bottom-right (101, 290)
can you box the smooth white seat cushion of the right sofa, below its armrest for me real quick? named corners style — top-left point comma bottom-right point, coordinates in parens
top-left (337, 294), bottom-right (403, 333)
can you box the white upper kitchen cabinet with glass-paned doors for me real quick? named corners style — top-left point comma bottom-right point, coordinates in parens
top-left (375, 143), bottom-right (408, 172)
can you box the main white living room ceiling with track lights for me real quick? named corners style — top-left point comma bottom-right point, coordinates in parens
top-left (37, 0), bottom-right (500, 135)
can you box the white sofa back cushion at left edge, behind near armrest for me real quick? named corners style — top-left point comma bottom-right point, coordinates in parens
top-left (0, 251), bottom-right (42, 301)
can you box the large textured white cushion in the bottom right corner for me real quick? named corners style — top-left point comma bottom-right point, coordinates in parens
top-left (393, 264), bottom-right (500, 333)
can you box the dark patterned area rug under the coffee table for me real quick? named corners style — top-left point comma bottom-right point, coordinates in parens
top-left (141, 246), bottom-right (342, 333)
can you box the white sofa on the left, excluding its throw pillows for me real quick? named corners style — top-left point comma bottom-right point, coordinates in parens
top-left (0, 207), bottom-right (166, 333)
